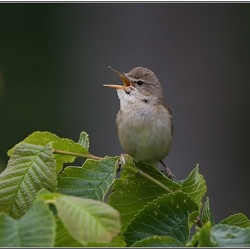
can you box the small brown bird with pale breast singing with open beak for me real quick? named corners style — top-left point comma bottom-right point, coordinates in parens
top-left (104, 66), bottom-right (175, 179)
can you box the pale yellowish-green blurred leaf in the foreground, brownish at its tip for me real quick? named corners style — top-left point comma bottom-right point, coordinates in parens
top-left (55, 194), bottom-right (120, 246)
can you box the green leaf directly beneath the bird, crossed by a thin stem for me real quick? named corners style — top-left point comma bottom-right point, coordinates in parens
top-left (109, 155), bottom-right (180, 231)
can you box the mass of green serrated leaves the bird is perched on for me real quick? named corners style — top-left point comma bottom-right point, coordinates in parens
top-left (0, 132), bottom-right (250, 247)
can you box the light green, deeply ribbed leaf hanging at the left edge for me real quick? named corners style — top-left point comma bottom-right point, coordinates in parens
top-left (0, 143), bottom-right (57, 218)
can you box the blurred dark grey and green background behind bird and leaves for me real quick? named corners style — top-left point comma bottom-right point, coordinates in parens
top-left (0, 3), bottom-right (250, 222)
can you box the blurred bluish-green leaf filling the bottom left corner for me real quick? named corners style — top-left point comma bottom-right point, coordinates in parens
top-left (0, 201), bottom-right (56, 247)
